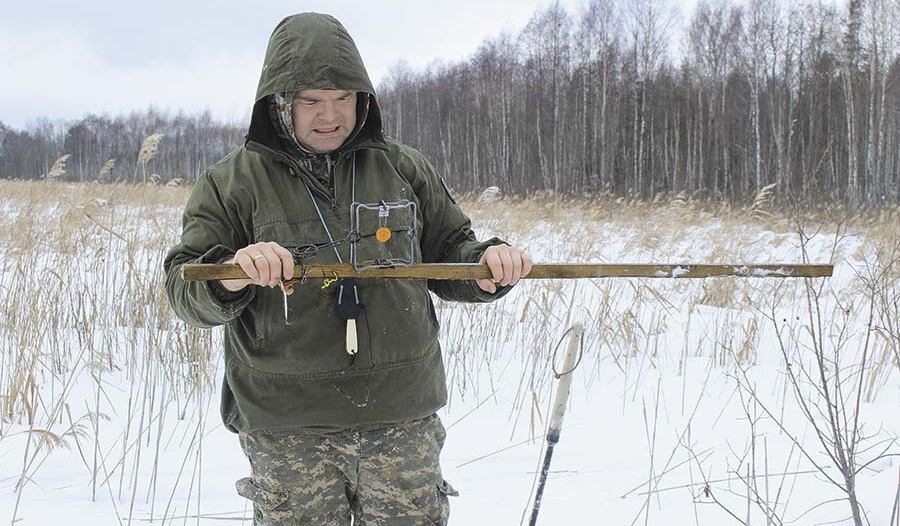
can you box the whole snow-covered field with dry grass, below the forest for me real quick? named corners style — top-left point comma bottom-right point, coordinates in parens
top-left (0, 183), bottom-right (900, 526)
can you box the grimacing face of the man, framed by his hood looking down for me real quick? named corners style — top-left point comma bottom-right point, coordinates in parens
top-left (293, 89), bottom-right (356, 153)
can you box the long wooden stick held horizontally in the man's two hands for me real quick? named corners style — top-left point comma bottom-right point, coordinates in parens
top-left (181, 263), bottom-right (834, 281)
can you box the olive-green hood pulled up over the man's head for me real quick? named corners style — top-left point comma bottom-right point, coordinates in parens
top-left (247, 13), bottom-right (384, 150)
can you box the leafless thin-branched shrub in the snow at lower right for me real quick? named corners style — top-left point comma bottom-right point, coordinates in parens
top-left (738, 223), bottom-right (897, 526)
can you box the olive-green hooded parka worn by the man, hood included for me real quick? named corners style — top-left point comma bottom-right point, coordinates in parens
top-left (164, 13), bottom-right (508, 431)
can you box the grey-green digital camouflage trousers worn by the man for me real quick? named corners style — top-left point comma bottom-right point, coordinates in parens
top-left (237, 415), bottom-right (456, 526)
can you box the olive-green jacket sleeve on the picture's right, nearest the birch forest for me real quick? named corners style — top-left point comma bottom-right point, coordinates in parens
top-left (399, 146), bottom-right (512, 303)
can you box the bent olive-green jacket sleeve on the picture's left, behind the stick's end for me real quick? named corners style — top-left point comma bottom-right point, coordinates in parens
top-left (163, 171), bottom-right (255, 327)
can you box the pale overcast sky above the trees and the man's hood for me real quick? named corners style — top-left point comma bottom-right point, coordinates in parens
top-left (0, 0), bottom-right (695, 128)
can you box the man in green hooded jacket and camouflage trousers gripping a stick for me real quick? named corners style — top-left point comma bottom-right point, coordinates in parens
top-left (165, 13), bottom-right (531, 525)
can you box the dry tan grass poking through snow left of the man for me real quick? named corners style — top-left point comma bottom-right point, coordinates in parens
top-left (0, 181), bottom-right (209, 524)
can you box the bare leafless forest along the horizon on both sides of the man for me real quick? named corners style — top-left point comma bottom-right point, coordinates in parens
top-left (0, 0), bottom-right (900, 204)
